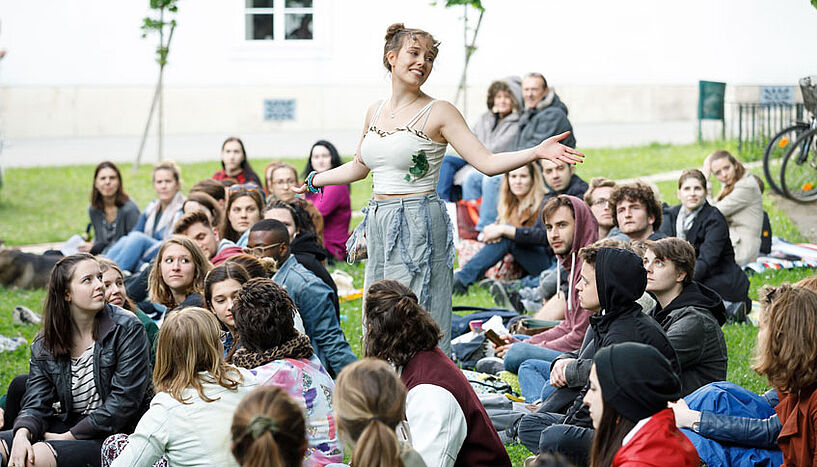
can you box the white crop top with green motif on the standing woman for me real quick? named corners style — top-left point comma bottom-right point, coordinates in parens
top-left (360, 100), bottom-right (448, 195)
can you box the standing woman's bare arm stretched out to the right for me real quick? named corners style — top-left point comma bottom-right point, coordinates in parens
top-left (438, 101), bottom-right (584, 175)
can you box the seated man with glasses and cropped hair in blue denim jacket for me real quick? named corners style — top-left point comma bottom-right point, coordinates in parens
top-left (245, 219), bottom-right (357, 377)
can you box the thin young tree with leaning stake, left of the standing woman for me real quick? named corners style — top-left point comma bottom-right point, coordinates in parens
top-left (133, 0), bottom-right (178, 171)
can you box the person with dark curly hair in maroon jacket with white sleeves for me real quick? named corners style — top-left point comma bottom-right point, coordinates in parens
top-left (364, 280), bottom-right (511, 466)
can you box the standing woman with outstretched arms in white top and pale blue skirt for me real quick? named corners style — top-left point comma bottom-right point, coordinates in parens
top-left (296, 24), bottom-right (584, 354)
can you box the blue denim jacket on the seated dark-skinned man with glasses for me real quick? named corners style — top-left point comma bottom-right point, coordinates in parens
top-left (272, 255), bottom-right (357, 376)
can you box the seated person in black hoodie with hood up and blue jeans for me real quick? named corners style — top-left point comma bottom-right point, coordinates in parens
top-left (505, 245), bottom-right (681, 465)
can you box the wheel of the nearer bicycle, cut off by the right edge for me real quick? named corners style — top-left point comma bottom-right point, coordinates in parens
top-left (780, 128), bottom-right (817, 203)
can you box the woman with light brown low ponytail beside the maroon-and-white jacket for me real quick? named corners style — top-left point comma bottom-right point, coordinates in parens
top-left (335, 358), bottom-right (426, 467)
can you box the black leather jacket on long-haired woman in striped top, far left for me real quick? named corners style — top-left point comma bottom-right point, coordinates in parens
top-left (14, 304), bottom-right (151, 440)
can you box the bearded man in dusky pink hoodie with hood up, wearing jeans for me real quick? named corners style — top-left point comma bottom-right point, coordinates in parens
top-left (496, 195), bottom-right (599, 373)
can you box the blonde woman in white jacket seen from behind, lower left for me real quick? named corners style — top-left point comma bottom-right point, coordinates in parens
top-left (107, 307), bottom-right (256, 467)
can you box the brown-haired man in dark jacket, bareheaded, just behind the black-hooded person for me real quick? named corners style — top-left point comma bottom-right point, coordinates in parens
top-left (643, 237), bottom-right (728, 396)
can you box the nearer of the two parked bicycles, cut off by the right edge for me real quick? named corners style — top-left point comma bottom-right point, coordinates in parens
top-left (780, 76), bottom-right (817, 203)
